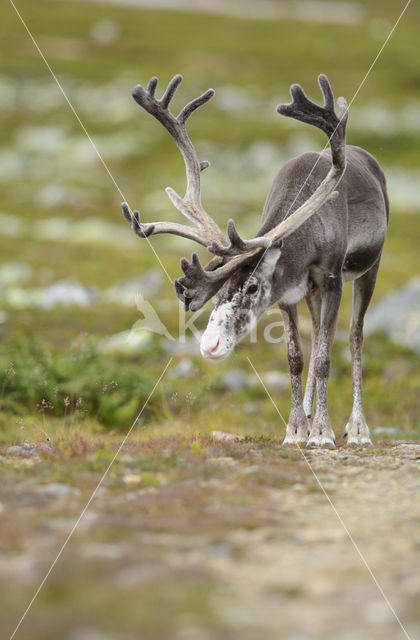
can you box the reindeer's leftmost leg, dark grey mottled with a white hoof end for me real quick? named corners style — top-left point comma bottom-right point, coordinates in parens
top-left (280, 305), bottom-right (308, 446)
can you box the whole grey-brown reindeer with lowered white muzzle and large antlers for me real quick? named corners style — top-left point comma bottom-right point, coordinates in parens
top-left (122, 75), bottom-right (389, 448)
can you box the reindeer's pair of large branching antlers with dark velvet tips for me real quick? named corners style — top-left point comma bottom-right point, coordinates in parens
top-left (122, 75), bottom-right (348, 311)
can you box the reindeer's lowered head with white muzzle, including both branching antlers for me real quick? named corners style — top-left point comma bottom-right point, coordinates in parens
top-left (122, 75), bottom-right (347, 359)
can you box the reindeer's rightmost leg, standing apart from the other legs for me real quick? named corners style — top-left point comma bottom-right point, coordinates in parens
top-left (344, 260), bottom-right (379, 446)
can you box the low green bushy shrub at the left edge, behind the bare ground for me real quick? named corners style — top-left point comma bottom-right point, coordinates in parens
top-left (0, 339), bottom-right (160, 429)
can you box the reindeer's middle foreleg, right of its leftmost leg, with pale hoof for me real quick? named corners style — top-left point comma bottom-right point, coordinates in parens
top-left (308, 269), bottom-right (343, 449)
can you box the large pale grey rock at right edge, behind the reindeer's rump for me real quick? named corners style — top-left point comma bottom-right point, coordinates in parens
top-left (365, 277), bottom-right (420, 353)
